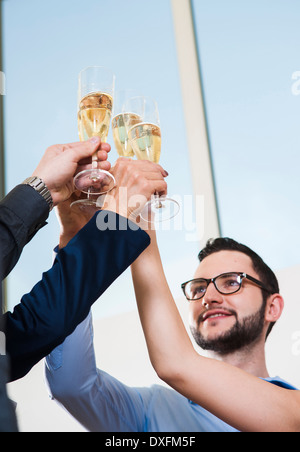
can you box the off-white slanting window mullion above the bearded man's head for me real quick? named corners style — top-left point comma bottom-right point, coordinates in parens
top-left (171, 0), bottom-right (220, 245)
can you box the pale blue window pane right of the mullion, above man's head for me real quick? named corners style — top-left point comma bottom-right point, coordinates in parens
top-left (192, 0), bottom-right (300, 269)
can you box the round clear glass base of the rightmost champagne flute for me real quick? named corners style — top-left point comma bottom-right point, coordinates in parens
top-left (140, 194), bottom-right (180, 224)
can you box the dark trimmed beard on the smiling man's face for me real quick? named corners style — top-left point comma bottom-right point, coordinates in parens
top-left (191, 302), bottom-right (266, 355)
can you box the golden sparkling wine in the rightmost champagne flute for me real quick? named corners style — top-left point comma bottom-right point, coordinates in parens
top-left (128, 122), bottom-right (161, 163)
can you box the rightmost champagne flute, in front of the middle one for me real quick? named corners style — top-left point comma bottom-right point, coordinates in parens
top-left (123, 96), bottom-right (179, 223)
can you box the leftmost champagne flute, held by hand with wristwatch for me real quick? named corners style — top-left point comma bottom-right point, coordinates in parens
top-left (71, 66), bottom-right (115, 213)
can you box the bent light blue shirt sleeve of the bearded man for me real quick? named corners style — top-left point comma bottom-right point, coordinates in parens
top-left (46, 315), bottom-right (145, 432)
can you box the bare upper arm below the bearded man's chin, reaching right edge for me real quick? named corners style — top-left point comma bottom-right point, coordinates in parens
top-left (168, 352), bottom-right (300, 432)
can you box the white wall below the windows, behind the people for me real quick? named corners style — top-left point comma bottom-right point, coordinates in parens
top-left (9, 266), bottom-right (300, 432)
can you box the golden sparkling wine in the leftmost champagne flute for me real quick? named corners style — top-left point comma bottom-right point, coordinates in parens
top-left (78, 92), bottom-right (113, 141)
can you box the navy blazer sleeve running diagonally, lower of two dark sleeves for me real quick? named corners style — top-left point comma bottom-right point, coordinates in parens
top-left (5, 211), bottom-right (150, 381)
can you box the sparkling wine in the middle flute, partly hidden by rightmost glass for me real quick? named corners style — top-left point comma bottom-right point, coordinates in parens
top-left (112, 113), bottom-right (142, 157)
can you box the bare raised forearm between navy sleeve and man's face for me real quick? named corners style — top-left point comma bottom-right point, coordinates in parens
top-left (131, 231), bottom-right (193, 380)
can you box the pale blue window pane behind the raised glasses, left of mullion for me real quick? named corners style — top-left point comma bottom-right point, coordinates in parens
top-left (3, 0), bottom-right (198, 313)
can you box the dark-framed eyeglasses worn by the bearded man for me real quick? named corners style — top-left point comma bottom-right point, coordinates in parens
top-left (181, 272), bottom-right (272, 301)
